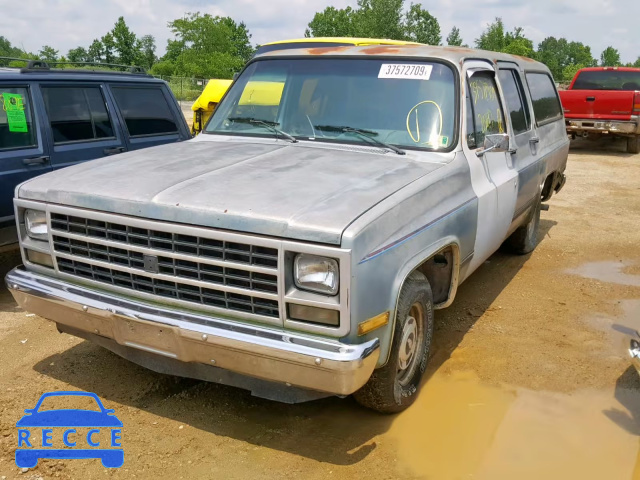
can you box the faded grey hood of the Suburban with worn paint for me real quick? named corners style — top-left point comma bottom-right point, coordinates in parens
top-left (19, 141), bottom-right (441, 244)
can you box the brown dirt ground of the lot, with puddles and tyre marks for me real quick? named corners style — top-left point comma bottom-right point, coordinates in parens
top-left (0, 137), bottom-right (640, 480)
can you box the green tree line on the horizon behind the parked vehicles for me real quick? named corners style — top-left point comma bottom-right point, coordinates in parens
top-left (0, 4), bottom-right (640, 82)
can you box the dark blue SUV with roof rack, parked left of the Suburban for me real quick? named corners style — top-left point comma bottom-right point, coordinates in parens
top-left (0, 57), bottom-right (191, 247)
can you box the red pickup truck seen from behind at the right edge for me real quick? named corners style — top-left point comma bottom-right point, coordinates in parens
top-left (560, 67), bottom-right (640, 153)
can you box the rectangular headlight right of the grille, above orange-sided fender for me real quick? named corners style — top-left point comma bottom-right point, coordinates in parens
top-left (293, 253), bottom-right (340, 295)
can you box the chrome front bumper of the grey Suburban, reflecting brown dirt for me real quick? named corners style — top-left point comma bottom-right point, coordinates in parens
top-left (6, 267), bottom-right (380, 395)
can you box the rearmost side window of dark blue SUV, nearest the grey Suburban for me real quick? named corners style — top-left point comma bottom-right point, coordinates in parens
top-left (112, 87), bottom-right (178, 137)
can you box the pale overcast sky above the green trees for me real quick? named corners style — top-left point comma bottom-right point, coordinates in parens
top-left (0, 0), bottom-right (640, 63)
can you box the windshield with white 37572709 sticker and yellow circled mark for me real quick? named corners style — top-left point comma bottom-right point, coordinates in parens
top-left (205, 58), bottom-right (457, 150)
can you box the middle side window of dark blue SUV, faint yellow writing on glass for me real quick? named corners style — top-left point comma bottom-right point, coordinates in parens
top-left (42, 87), bottom-right (114, 143)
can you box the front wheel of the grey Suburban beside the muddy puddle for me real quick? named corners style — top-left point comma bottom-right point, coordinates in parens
top-left (353, 272), bottom-right (433, 413)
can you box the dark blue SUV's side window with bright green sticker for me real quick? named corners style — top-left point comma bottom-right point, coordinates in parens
top-left (0, 86), bottom-right (36, 150)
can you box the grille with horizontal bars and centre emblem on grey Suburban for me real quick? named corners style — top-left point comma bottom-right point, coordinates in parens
top-left (51, 213), bottom-right (279, 318)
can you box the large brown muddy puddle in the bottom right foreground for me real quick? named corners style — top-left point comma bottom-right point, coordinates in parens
top-left (389, 373), bottom-right (640, 480)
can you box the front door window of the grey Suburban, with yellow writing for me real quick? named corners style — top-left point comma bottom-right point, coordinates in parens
top-left (467, 72), bottom-right (505, 148)
